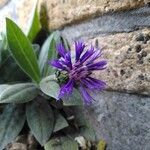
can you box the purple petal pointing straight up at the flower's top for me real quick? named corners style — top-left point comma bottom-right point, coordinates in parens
top-left (75, 41), bottom-right (85, 62)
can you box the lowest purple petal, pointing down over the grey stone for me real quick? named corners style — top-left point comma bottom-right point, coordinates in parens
top-left (79, 85), bottom-right (94, 105)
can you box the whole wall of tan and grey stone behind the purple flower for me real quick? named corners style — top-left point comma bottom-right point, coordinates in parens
top-left (0, 0), bottom-right (150, 150)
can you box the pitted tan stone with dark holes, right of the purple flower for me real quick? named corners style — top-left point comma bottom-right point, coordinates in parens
top-left (90, 29), bottom-right (150, 95)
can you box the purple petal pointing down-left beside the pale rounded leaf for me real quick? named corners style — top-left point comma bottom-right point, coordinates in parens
top-left (59, 80), bottom-right (74, 98)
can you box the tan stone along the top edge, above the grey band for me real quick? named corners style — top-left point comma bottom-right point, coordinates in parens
top-left (38, 0), bottom-right (144, 29)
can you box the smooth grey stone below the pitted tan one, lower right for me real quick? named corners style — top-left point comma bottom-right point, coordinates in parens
top-left (86, 92), bottom-right (150, 150)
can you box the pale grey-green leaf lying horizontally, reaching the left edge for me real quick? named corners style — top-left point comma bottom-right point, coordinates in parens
top-left (0, 83), bottom-right (38, 103)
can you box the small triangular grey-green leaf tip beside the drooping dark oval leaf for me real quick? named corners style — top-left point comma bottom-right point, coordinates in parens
top-left (53, 112), bottom-right (68, 132)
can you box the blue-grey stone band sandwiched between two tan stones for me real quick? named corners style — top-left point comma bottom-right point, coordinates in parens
top-left (62, 6), bottom-right (150, 40)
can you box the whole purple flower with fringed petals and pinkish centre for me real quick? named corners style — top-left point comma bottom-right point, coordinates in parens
top-left (50, 41), bottom-right (107, 104)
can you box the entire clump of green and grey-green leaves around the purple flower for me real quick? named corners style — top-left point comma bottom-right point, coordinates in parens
top-left (0, 3), bottom-right (95, 150)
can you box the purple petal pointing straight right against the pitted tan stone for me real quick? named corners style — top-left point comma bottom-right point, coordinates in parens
top-left (87, 60), bottom-right (107, 70)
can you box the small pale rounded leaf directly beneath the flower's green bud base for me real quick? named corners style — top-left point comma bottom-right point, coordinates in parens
top-left (40, 75), bottom-right (60, 99)
